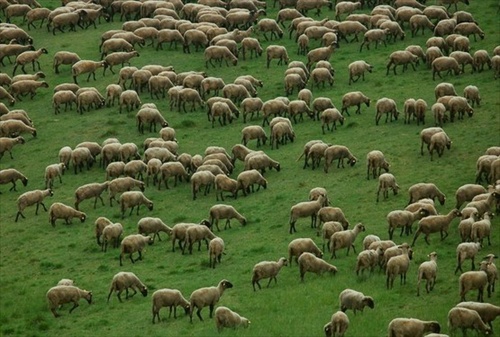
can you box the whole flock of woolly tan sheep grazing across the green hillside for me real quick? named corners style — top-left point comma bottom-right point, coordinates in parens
top-left (0, 0), bottom-right (500, 337)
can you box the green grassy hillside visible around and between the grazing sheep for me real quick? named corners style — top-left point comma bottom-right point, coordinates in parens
top-left (0, 0), bottom-right (500, 336)
